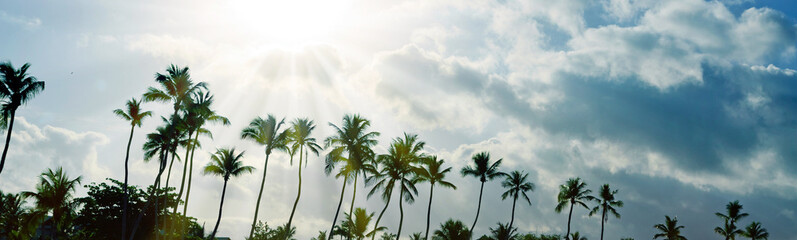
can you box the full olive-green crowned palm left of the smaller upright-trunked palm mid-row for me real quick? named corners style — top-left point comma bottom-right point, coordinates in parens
top-left (368, 133), bottom-right (426, 239)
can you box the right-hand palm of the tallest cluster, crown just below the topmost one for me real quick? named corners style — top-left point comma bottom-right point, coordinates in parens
top-left (178, 91), bottom-right (230, 225)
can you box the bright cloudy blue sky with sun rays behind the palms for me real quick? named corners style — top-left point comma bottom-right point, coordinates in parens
top-left (0, 0), bottom-right (797, 239)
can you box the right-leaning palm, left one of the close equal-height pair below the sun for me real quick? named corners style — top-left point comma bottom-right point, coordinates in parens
top-left (241, 114), bottom-right (287, 238)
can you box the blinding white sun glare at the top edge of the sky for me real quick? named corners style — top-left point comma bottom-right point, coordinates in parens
top-left (229, 0), bottom-right (351, 47)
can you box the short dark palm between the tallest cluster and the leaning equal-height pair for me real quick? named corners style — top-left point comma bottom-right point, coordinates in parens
top-left (202, 148), bottom-right (255, 239)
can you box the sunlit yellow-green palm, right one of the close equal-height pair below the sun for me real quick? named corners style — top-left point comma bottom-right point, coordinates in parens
top-left (286, 118), bottom-right (321, 234)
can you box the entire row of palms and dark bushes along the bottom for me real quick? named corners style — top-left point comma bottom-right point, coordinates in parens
top-left (0, 63), bottom-right (768, 240)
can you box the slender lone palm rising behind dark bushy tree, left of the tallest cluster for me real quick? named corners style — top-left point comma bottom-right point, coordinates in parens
top-left (113, 98), bottom-right (152, 240)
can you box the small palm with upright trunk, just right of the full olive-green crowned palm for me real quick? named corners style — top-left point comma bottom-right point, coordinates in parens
top-left (416, 156), bottom-right (457, 239)
